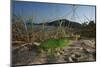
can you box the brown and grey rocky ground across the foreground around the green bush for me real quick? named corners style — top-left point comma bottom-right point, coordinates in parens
top-left (12, 39), bottom-right (96, 65)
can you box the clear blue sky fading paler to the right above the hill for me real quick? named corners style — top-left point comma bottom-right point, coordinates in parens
top-left (12, 1), bottom-right (95, 23)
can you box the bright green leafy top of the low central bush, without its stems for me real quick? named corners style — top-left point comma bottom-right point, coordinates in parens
top-left (40, 38), bottom-right (69, 50)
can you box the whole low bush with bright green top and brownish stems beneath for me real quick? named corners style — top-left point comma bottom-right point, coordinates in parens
top-left (39, 38), bottom-right (69, 56)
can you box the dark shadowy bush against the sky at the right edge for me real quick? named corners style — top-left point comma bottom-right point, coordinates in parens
top-left (81, 21), bottom-right (96, 38)
